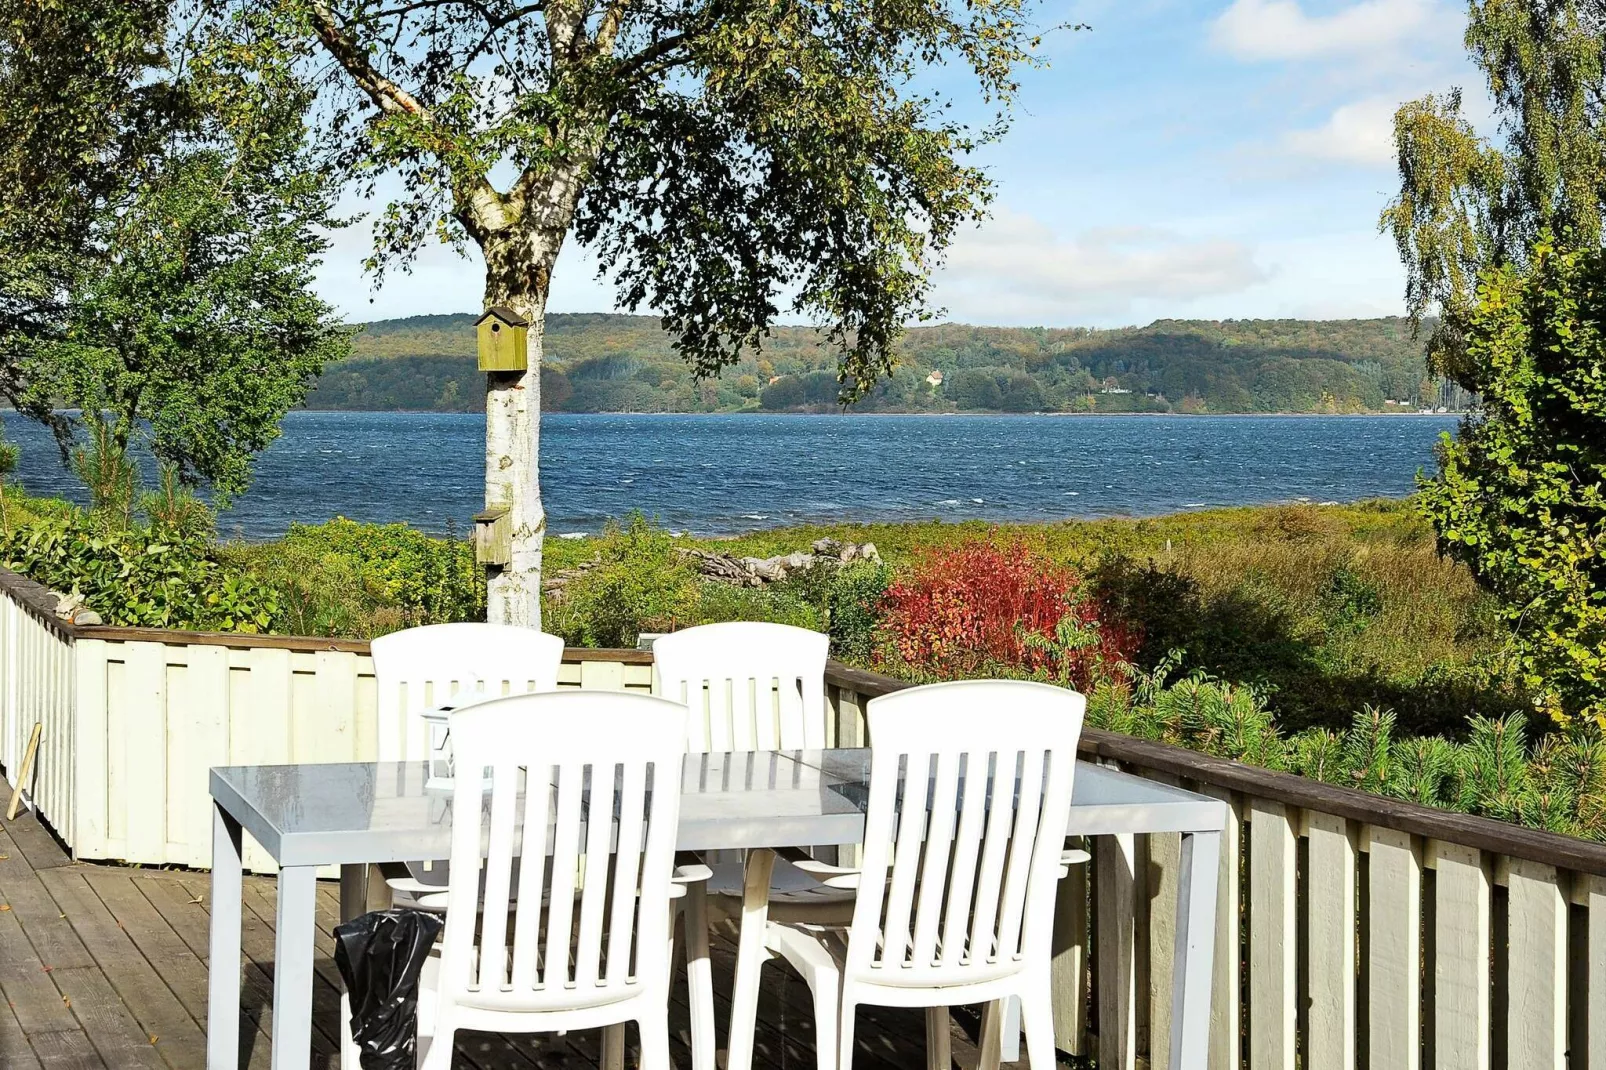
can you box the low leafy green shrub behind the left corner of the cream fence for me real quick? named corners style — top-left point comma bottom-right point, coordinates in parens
top-left (0, 513), bottom-right (279, 631)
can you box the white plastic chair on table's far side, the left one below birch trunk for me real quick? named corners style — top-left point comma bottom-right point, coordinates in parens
top-left (369, 623), bottom-right (564, 911)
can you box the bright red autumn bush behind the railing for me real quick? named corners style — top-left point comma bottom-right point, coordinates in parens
top-left (880, 541), bottom-right (1139, 691)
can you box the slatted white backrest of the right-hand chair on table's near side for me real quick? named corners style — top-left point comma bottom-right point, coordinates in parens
top-left (848, 681), bottom-right (1086, 985)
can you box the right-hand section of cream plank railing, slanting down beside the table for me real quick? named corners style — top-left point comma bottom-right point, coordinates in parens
top-left (825, 667), bottom-right (1606, 1070)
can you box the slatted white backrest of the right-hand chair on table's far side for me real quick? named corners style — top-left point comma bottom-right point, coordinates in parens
top-left (652, 622), bottom-right (830, 752)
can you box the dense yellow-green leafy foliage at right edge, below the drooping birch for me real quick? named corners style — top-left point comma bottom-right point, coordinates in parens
top-left (1420, 238), bottom-right (1606, 725)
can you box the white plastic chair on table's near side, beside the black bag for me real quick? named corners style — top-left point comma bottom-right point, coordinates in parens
top-left (356, 691), bottom-right (687, 1070)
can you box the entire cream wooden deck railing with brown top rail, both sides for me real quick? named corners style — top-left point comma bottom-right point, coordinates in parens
top-left (0, 570), bottom-right (1606, 1070)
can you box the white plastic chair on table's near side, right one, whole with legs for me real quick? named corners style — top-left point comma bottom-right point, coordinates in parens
top-left (732, 681), bottom-right (1086, 1070)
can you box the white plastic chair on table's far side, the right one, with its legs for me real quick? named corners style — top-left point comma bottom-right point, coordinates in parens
top-left (652, 622), bottom-right (851, 1070)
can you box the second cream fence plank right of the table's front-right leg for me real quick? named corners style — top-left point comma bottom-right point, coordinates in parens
top-left (1304, 813), bottom-right (1360, 1070)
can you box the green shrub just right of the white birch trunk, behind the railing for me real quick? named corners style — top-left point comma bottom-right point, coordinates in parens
top-left (546, 513), bottom-right (700, 646)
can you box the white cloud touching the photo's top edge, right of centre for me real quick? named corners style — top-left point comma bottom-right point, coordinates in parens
top-left (1211, 0), bottom-right (1437, 59)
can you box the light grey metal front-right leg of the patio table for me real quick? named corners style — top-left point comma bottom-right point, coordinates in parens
top-left (1171, 832), bottom-right (1235, 1070)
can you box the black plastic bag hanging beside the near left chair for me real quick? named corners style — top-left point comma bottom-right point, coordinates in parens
top-left (334, 911), bottom-right (445, 1070)
